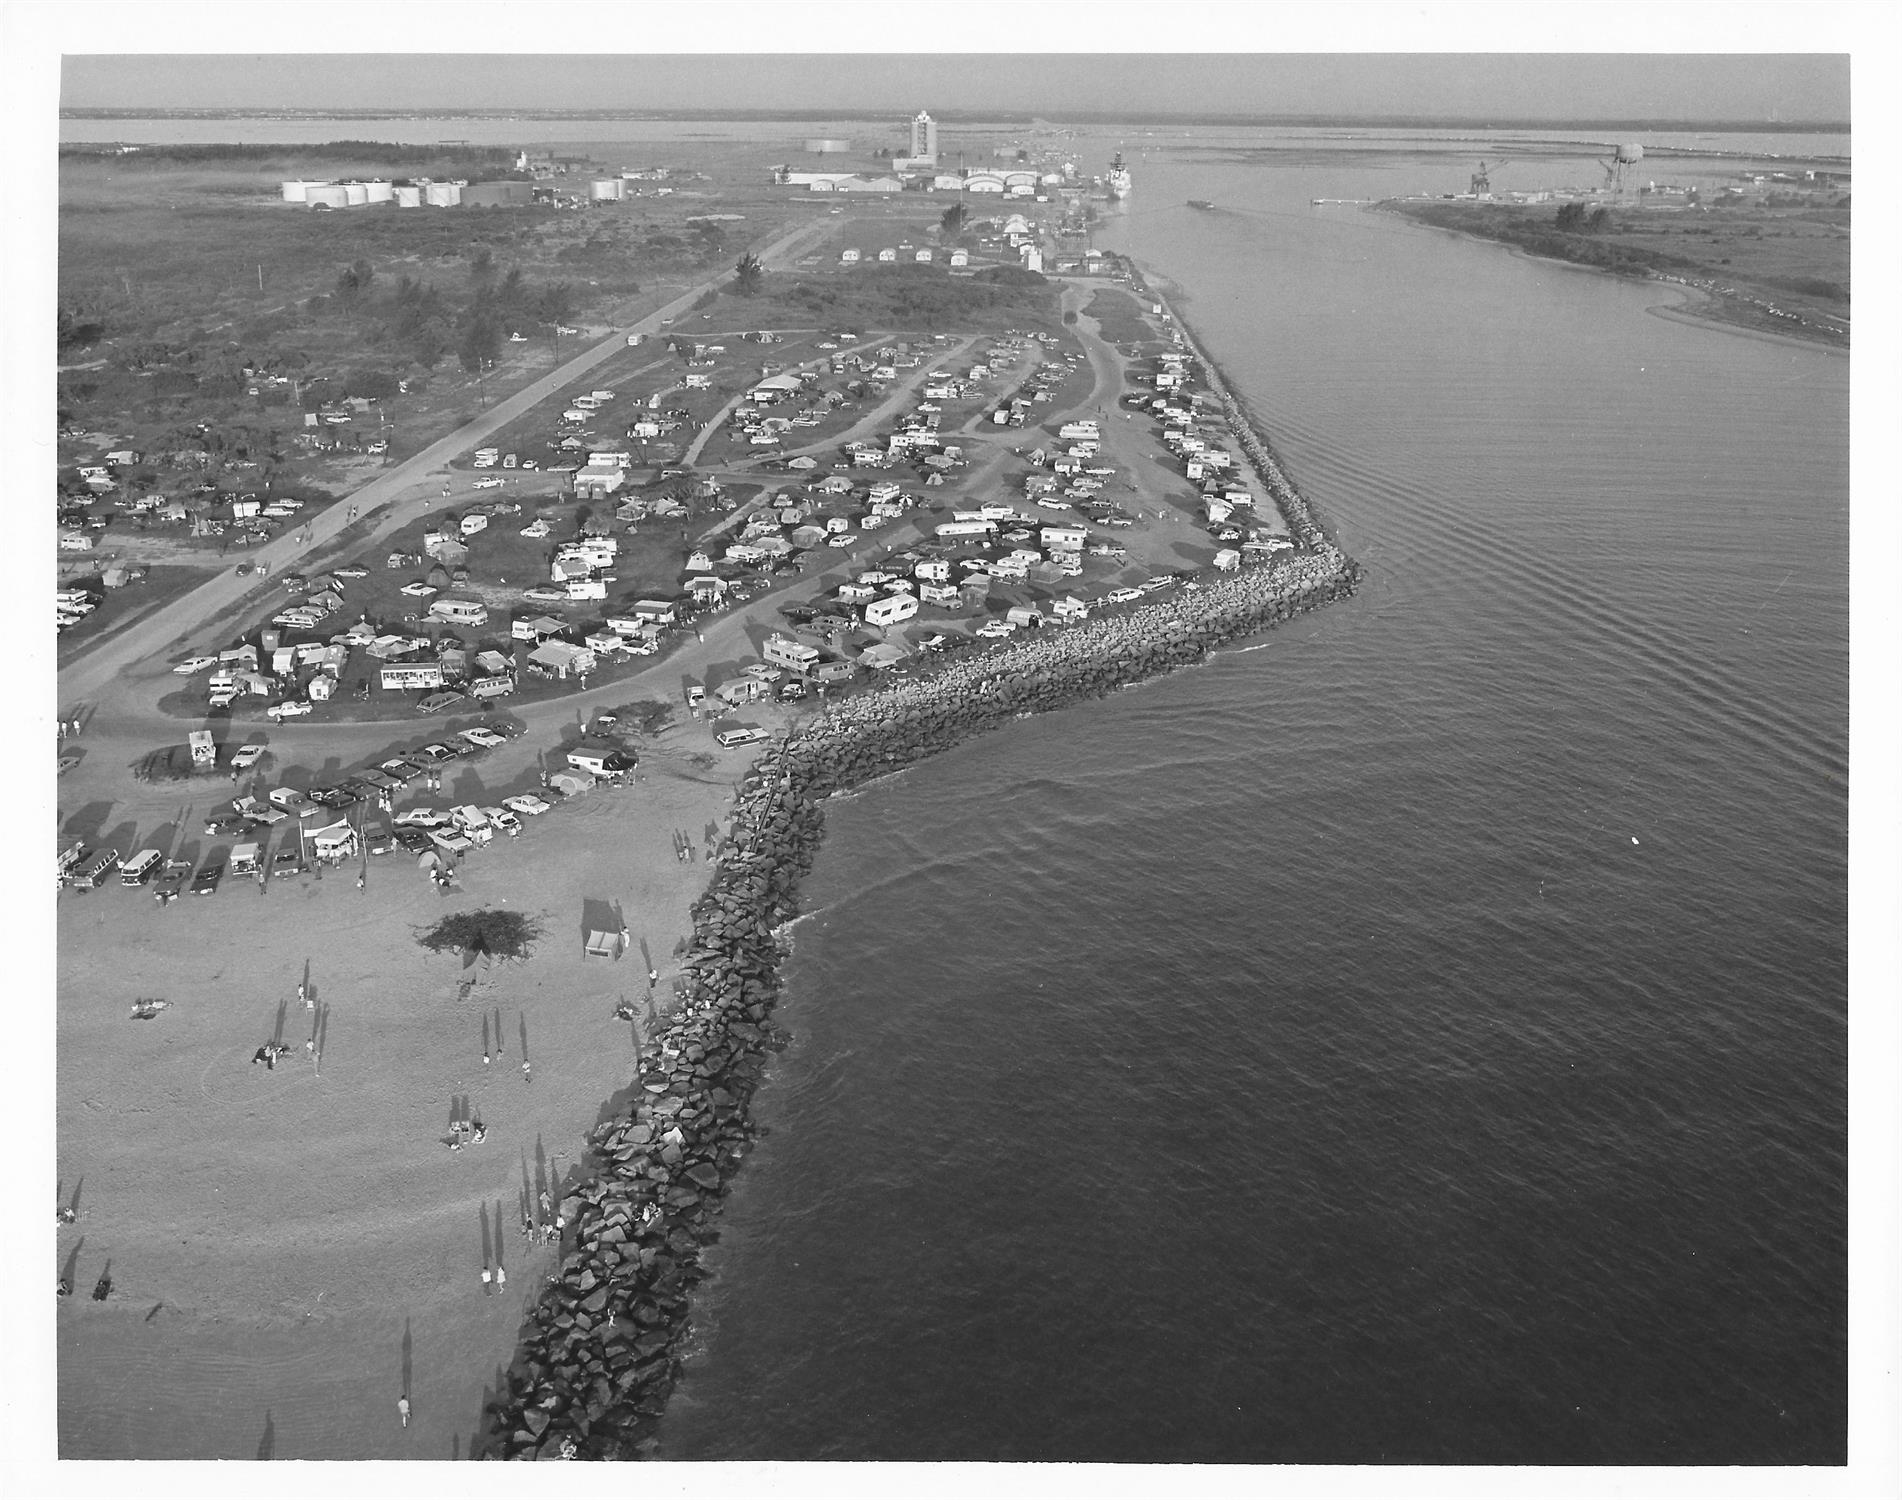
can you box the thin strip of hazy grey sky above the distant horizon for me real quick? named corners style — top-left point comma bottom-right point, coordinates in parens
top-left (61, 49), bottom-right (1849, 122)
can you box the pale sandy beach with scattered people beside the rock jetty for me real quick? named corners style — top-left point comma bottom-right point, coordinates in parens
top-left (57, 728), bottom-right (768, 1458)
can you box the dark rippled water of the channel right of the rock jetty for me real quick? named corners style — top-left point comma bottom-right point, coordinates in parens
top-left (662, 141), bottom-right (1849, 1464)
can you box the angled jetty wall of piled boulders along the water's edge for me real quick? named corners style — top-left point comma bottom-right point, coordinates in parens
top-left (472, 283), bottom-right (1362, 1458)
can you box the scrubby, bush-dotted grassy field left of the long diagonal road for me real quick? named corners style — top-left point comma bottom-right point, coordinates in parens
top-left (59, 150), bottom-right (814, 555)
